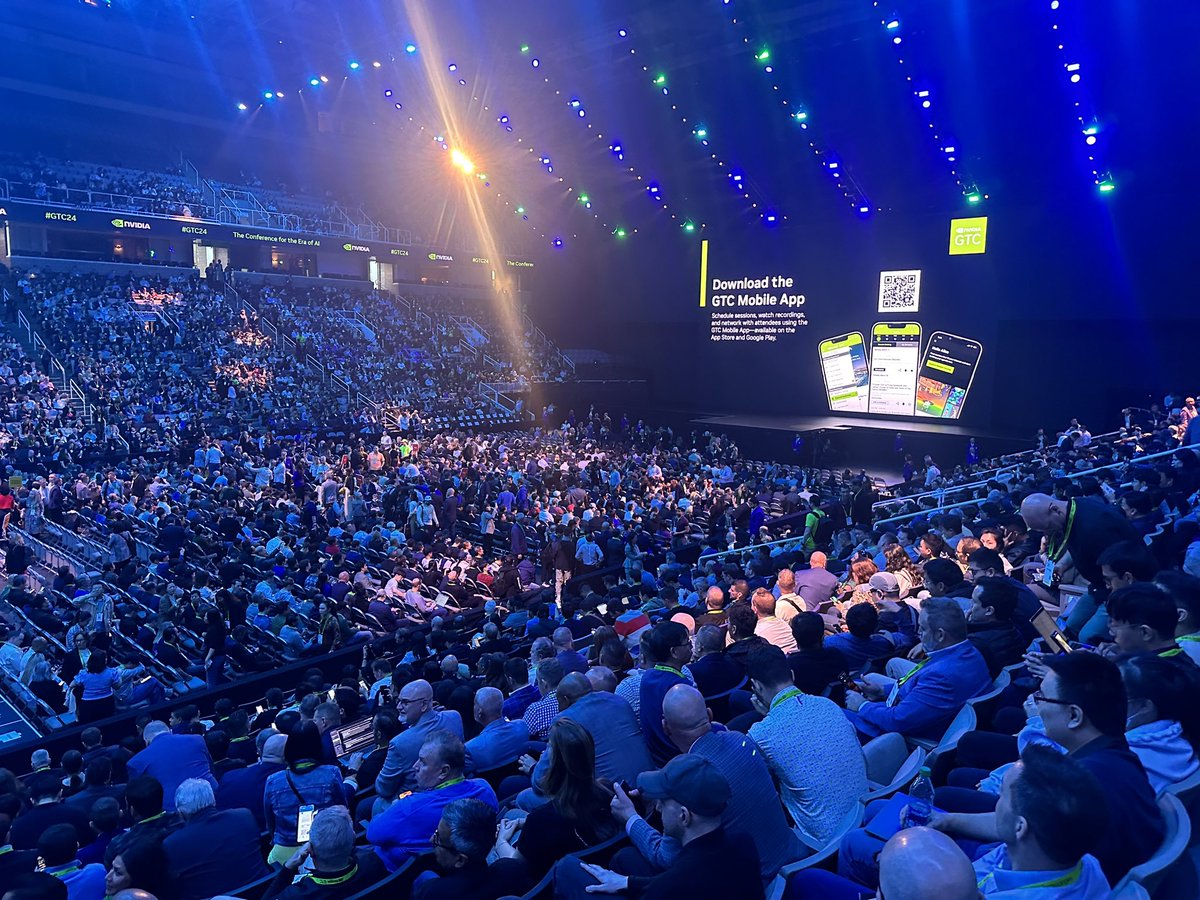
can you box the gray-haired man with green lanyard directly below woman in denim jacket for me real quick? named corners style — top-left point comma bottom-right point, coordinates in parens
top-left (266, 806), bottom-right (388, 900)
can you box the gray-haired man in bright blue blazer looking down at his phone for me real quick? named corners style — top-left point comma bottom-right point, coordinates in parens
top-left (846, 596), bottom-right (991, 740)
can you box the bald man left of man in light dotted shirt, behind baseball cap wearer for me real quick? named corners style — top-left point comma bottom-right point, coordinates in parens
top-left (612, 684), bottom-right (805, 882)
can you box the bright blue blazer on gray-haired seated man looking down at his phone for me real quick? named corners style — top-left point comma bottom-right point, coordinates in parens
top-left (846, 641), bottom-right (991, 740)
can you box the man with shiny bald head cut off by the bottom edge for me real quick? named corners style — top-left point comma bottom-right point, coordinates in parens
top-left (787, 828), bottom-right (982, 900)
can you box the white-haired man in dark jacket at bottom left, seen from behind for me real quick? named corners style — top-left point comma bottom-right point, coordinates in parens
top-left (162, 778), bottom-right (268, 900)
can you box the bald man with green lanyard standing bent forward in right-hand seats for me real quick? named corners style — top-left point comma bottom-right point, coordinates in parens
top-left (1021, 493), bottom-right (1141, 595)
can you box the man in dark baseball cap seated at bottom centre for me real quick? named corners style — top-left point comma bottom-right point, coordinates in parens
top-left (568, 754), bottom-right (763, 900)
